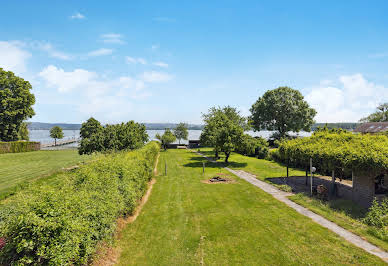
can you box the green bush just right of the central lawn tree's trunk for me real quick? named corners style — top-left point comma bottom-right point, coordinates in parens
top-left (235, 134), bottom-right (268, 159)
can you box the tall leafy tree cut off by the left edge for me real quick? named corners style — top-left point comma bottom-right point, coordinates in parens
top-left (0, 68), bottom-right (35, 141)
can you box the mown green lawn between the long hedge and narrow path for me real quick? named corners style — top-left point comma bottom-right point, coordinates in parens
top-left (117, 150), bottom-right (384, 265)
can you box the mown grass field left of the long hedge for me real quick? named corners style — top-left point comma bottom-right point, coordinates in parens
top-left (0, 149), bottom-right (91, 199)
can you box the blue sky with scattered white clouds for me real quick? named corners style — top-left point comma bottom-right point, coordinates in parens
top-left (0, 0), bottom-right (388, 123)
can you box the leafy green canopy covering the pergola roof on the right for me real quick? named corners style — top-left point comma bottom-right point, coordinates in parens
top-left (274, 131), bottom-right (388, 175)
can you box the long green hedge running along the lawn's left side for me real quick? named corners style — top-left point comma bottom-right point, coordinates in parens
top-left (0, 142), bottom-right (160, 265)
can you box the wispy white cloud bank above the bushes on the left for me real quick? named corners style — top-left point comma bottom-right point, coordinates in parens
top-left (39, 65), bottom-right (167, 121)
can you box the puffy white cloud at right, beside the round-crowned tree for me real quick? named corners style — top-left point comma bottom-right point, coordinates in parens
top-left (306, 74), bottom-right (388, 122)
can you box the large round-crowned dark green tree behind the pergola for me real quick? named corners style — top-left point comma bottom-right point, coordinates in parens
top-left (250, 87), bottom-right (317, 138)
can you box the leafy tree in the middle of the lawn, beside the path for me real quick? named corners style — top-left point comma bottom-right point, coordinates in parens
top-left (200, 106), bottom-right (247, 162)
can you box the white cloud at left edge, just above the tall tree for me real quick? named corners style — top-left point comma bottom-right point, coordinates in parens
top-left (0, 41), bottom-right (31, 74)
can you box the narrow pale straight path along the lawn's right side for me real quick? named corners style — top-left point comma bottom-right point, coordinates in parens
top-left (198, 153), bottom-right (388, 263)
